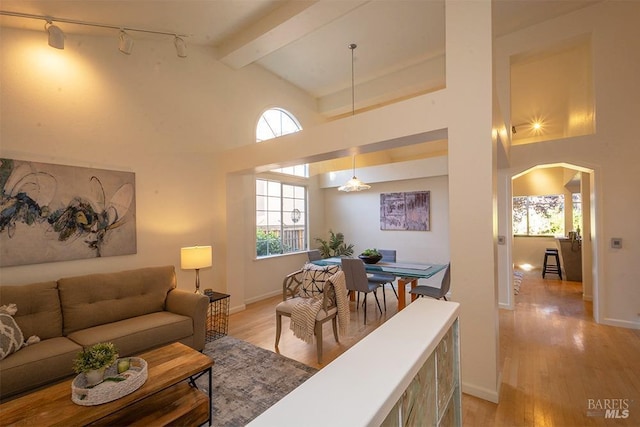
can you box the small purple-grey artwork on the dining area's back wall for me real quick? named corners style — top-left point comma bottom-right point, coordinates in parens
top-left (380, 191), bottom-right (431, 231)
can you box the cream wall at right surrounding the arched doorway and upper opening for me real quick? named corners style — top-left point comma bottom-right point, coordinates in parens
top-left (495, 1), bottom-right (640, 329)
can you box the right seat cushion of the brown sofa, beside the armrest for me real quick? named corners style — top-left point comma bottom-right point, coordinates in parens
top-left (68, 311), bottom-right (193, 356)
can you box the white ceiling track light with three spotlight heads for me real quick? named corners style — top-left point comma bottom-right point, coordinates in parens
top-left (0, 10), bottom-right (188, 58)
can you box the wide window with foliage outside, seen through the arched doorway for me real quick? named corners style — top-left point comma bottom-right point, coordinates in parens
top-left (513, 195), bottom-right (564, 236)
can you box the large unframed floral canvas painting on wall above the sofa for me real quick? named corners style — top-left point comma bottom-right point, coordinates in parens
top-left (0, 158), bottom-right (137, 267)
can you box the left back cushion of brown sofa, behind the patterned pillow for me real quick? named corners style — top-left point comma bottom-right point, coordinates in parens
top-left (0, 282), bottom-right (62, 340)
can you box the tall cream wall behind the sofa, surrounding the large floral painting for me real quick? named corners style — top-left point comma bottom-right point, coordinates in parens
top-left (0, 27), bottom-right (321, 298)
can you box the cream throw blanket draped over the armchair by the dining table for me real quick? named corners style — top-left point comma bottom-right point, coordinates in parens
top-left (289, 271), bottom-right (351, 344)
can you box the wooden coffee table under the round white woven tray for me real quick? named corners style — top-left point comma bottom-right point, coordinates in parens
top-left (0, 343), bottom-right (213, 426)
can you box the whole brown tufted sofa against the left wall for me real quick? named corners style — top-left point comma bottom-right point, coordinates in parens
top-left (0, 266), bottom-right (209, 400)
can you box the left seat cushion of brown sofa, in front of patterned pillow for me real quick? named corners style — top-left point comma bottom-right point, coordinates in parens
top-left (0, 337), bottom-right (82, 400)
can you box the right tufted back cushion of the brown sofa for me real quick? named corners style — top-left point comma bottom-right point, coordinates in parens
top-left (58, 265), bottom-right (176, 336)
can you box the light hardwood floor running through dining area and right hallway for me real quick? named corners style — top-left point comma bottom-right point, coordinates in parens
top-left (229, 271), bottom-right (640, 427)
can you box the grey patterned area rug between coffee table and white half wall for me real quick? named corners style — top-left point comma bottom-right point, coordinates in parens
top-left (197, 336), bottom-right (317, 427)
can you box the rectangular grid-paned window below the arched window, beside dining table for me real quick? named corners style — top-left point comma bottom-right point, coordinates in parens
top-left (256, 179), bottom-right (307, 257)
